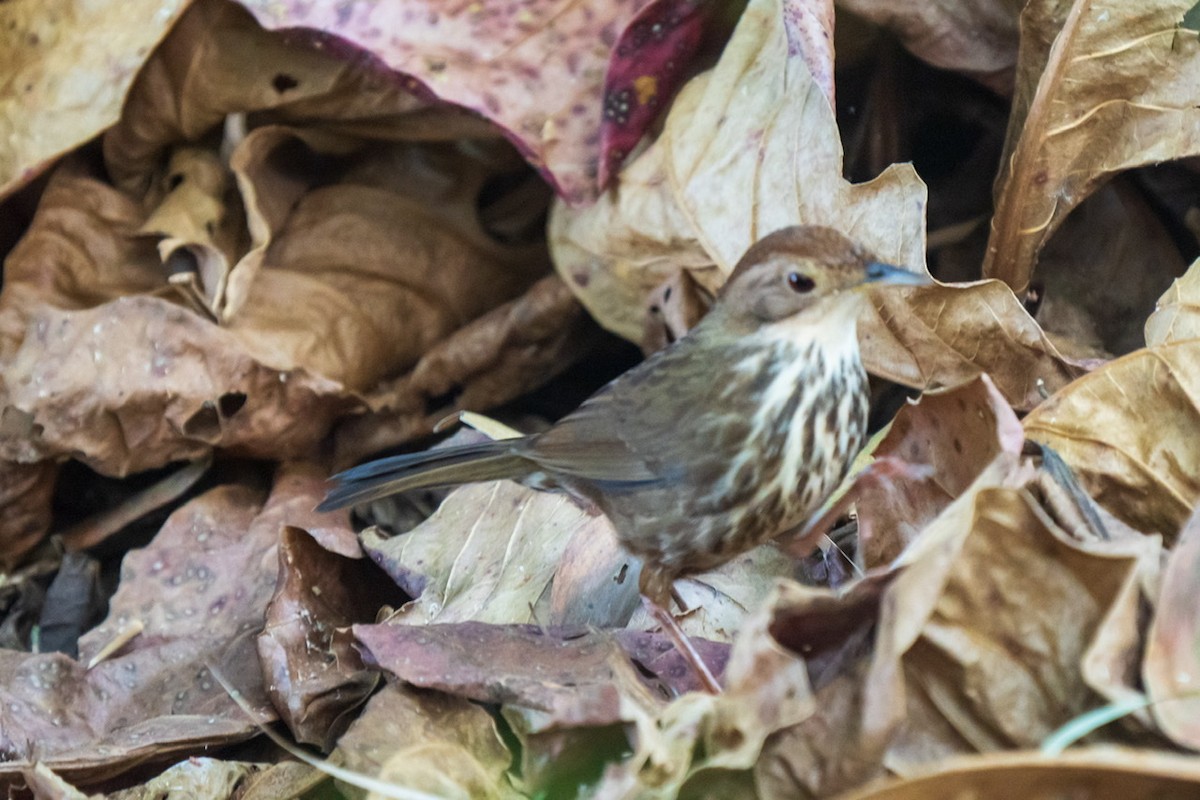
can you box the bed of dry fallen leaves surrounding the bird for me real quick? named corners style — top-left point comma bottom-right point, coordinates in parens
top-left (0, 0), bottom-right (1200, 799)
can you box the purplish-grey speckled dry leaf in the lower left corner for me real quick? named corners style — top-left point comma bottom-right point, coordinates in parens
top-left (0, 481), bottom-right (274, 782)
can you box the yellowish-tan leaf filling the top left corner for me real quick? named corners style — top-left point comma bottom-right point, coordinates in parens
top-left (0, 0), bottom-right (187, 197)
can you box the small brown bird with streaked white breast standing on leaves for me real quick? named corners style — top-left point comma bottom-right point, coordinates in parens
top-left (318, 225), bottom-right (931, 692)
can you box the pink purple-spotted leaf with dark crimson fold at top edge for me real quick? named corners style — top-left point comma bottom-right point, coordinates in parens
top-left (245, 0), bottom-right (703, 203)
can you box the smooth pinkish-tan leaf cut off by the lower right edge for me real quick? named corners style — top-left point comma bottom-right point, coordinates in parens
top-left (1141, 503), bottom-right (1200, 750)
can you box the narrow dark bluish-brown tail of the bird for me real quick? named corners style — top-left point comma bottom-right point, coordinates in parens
top-left (317, 440), bottom-right (535, 511)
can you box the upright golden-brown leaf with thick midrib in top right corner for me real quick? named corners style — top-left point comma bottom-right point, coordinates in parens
top-left (984, 0), bottom-right (1200, 291)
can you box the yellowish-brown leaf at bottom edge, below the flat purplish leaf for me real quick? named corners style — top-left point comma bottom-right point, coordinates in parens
top-left (337, 684), bottom-right (523, 800)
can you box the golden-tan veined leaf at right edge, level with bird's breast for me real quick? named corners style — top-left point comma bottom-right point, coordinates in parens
top-left (1025, 339), bottom-right (1200, 537)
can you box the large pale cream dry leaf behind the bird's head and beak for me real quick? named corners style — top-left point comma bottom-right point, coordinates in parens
top-left (550, 0), bottom-right (1078, 408)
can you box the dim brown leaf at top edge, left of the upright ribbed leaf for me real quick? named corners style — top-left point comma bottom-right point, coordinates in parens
top-left (838, 0), bottom-right (1022, 95)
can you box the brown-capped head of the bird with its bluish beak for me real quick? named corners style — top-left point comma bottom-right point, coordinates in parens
top-left (718, 225), bottom-right (930, 326)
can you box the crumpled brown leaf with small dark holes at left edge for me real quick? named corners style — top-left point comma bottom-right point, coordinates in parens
top-left (0, 159), bottom-right (358, 475)
